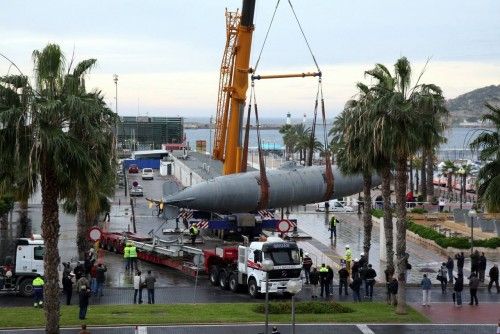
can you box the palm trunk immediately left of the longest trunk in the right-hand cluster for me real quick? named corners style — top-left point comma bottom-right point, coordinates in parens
top-left (381, 164), bottom-right (394, 272)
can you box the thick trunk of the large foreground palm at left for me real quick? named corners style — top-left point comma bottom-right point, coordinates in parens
top-left (41, 158), bottom-right (60, 334)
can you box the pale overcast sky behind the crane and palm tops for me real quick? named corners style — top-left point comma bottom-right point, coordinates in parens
top-left (0, 0), bottom-right (500, 117)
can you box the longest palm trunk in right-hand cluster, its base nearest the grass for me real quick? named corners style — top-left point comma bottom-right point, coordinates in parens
top-left (396, 156), bottom-right (408, 314)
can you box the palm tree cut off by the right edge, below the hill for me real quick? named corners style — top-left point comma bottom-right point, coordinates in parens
top-left (470, 103), bottom-right (500, 212)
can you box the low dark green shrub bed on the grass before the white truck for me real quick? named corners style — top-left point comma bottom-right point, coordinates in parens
top-left (254, 301), bottom-right (354, 314)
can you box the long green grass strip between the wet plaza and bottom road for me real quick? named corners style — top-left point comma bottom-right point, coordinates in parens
top-left (0, 301), bottom-right (429, 328)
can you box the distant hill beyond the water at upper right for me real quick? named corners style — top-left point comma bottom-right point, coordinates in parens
top-left (446, 85), bottom-right (500, 123)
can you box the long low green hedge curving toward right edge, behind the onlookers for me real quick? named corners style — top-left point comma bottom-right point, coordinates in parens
top-left (407, 221), bottom-right (500, 249)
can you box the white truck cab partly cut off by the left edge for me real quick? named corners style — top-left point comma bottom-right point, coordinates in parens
top-left (0, 235), bottom-right (44, 296)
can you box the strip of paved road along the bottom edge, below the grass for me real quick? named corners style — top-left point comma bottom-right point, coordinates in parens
top-left (0, 324), bottom-right (496, 334)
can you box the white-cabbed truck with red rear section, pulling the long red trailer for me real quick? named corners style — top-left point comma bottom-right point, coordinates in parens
top-left (203, 237), bottom-right (302, 298)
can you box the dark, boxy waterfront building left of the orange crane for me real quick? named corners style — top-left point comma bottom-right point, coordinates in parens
top-left (117, 116), bottom-right (185, 151)
